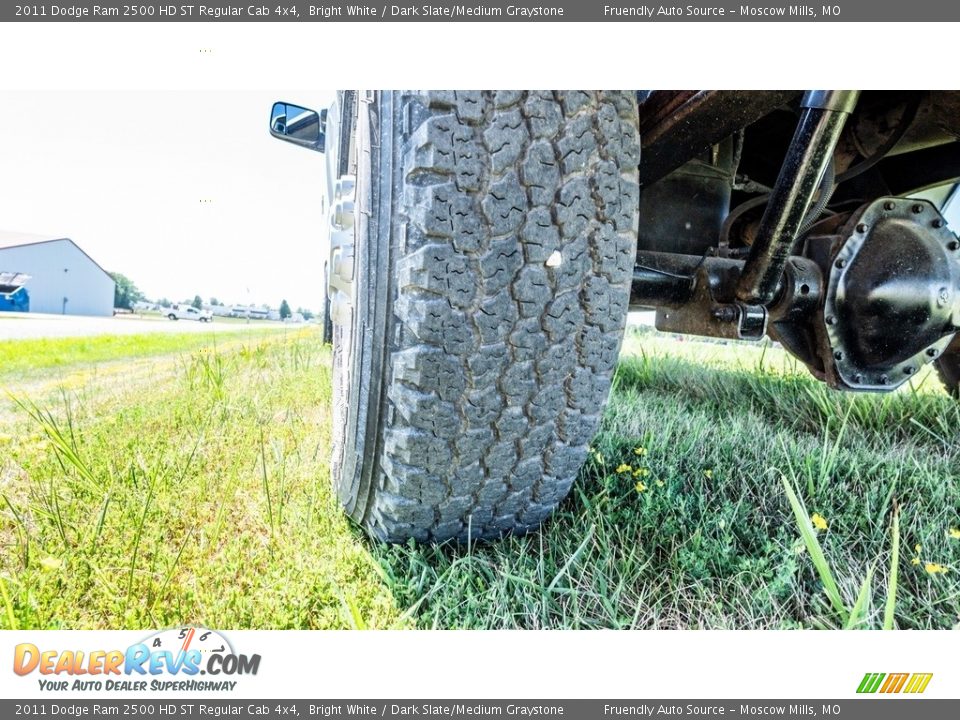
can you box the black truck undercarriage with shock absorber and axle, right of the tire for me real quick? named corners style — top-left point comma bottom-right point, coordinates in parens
top-left (631, 91), bottom-right (960, 391)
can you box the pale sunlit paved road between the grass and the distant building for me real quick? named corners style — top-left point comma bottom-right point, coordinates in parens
top-left (0, 313), bottom-right (298, 341)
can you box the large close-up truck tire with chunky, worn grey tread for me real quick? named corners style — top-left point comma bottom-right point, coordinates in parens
top-left (332, 91), bottom-right (640, 542)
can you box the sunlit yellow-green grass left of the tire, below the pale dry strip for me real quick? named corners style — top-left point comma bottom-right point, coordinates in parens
top-left (0, 332), bottom-right (400, 628)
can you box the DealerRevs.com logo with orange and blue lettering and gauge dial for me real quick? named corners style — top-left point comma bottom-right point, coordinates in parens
top-left (13, 627), bottom-right (260, 692)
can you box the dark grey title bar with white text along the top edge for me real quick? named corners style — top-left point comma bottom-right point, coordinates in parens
top-left (0, 0), bottom-right (960, 22)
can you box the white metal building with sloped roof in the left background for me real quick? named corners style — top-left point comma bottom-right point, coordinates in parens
top-left (0, 231), bottom-right (114, 315)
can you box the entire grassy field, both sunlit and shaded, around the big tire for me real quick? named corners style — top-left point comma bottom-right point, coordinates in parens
top-left (0, 328), bottom-right (960, 629)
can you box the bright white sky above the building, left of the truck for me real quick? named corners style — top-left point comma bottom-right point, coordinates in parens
top-left (0, 90), bottom-right (333, 310)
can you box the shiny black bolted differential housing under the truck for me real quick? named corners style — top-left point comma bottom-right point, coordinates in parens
top-left (817, 197), bottom-right (960, 391)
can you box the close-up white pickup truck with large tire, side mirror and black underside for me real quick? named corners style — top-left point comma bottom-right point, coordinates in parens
top-left (270, 90), bottom-right (960, 542)
